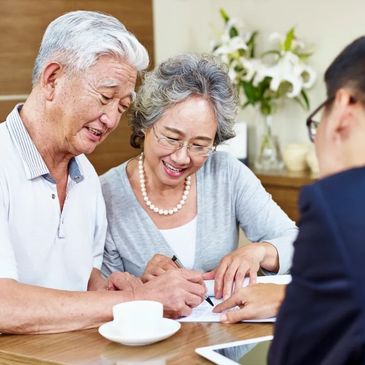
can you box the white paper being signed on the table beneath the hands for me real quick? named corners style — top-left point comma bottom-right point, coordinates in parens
top-left (179, 275), bottom-right (291, 322)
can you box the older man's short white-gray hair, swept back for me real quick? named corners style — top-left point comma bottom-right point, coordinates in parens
top-left (32, 10), bottom-right (149, 86)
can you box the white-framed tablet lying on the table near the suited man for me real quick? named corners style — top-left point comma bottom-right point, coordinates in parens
top-left (195, 336), bottom-right (273, 365)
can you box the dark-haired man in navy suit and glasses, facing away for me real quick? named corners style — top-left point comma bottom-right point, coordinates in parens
top-left (269, 37), bottom-right (365, 365)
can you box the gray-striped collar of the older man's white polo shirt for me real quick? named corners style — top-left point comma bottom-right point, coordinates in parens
top-left (6, 104), bottom-right (84, 183)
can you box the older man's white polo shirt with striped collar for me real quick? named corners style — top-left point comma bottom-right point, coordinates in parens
top-left (0, 106), bottom-right (107, 290)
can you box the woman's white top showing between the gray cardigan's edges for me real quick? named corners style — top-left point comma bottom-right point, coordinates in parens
top-left (160, 216), bottom-right (197, 269)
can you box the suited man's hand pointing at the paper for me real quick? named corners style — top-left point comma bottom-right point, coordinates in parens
top-left (213, 284), bottom-right (286, 323)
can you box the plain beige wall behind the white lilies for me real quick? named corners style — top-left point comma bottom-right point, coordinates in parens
top-left (153, 0), bottom-right (365, 161)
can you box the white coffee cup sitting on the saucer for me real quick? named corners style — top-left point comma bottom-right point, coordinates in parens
top-left (113, 300), bottom-right (163, 338)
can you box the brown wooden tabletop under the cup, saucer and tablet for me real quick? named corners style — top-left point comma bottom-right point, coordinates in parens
top-left (0, 323), bottom-right (273, 365)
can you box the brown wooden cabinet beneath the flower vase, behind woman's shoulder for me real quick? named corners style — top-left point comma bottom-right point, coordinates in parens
top-left (252, 169), bottom-right (318, 222)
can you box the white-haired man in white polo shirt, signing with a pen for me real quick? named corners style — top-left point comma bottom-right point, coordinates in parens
top-left (0, 11), bottom-right (205, 333)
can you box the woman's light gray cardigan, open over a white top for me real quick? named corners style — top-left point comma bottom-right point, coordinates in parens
top-left (101, 152), bottom-right (297, 276)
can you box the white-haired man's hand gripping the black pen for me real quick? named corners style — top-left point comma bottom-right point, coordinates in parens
top-left (134, 269), bottom-right (206, 318)
